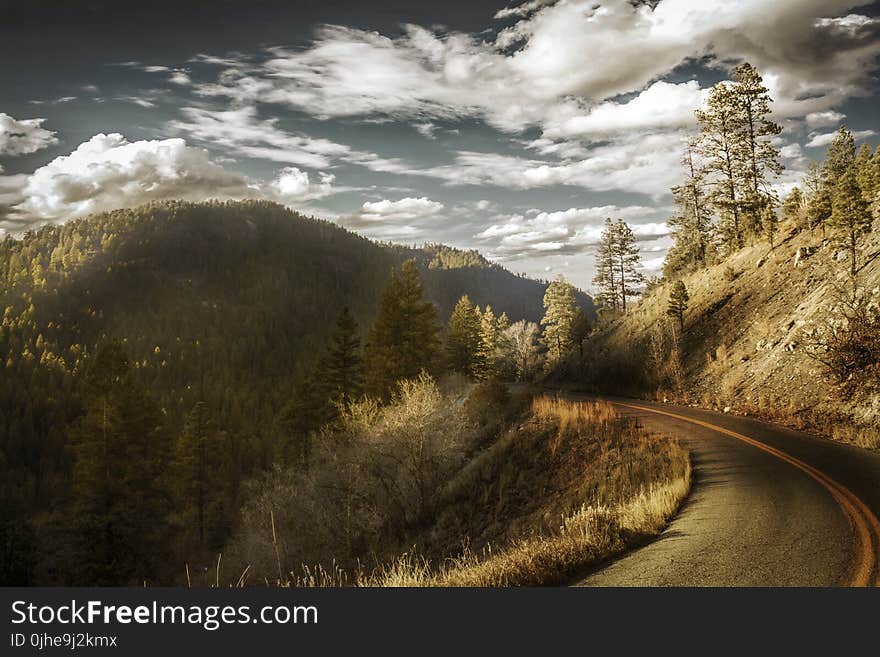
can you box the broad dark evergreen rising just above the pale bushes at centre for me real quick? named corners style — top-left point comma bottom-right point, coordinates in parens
top-left (364, 260), bottom-right (438, 399)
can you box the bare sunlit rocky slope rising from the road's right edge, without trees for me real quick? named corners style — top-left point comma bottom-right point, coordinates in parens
top-left (579, 223), bottom-right (880, 446)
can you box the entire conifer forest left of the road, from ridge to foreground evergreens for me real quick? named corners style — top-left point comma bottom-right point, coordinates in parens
top-left (0, 197), bottom-right (592, 584)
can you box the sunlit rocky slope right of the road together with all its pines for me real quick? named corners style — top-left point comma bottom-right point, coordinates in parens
top-left (576, 64), bottom-right (880, 447)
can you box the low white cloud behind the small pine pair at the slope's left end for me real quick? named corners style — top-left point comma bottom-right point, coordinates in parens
top-left (475, 205), bottom-right (669, 260)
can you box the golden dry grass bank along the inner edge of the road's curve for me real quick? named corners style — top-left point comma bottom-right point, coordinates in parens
top-left (359, 397), bottom-right (690, 586)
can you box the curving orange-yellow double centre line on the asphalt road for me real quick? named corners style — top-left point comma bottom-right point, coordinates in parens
top-left (613, 402), bottom-right (880, 586)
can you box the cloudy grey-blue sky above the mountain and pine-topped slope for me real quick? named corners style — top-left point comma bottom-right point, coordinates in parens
top-left (0, 0), bottom-right (880, 290)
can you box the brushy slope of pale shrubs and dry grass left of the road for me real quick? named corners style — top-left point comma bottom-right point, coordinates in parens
top-left (229, 379), bottom-right (690, 586)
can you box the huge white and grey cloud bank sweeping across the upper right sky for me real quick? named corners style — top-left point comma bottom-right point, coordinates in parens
top-left (196, 0), bottom-right (880, 131)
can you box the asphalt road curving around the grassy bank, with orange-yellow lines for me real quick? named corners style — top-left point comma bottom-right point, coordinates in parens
top-left (579, 400), bottom-right (880, 586)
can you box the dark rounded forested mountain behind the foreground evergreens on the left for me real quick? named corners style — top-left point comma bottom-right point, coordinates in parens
top-left (0, 197), bottom-right (592, 582)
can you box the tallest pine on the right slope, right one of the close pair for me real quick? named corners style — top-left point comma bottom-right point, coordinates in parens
top-left (733, 62), bottom-right (783, 233)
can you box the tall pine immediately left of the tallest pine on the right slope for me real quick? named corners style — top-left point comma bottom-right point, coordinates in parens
top-left (695, 82), bottom-right (748, 247)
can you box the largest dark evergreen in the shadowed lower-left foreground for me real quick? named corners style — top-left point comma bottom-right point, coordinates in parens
top-left (68, 343), bottom-right (171, 585)
